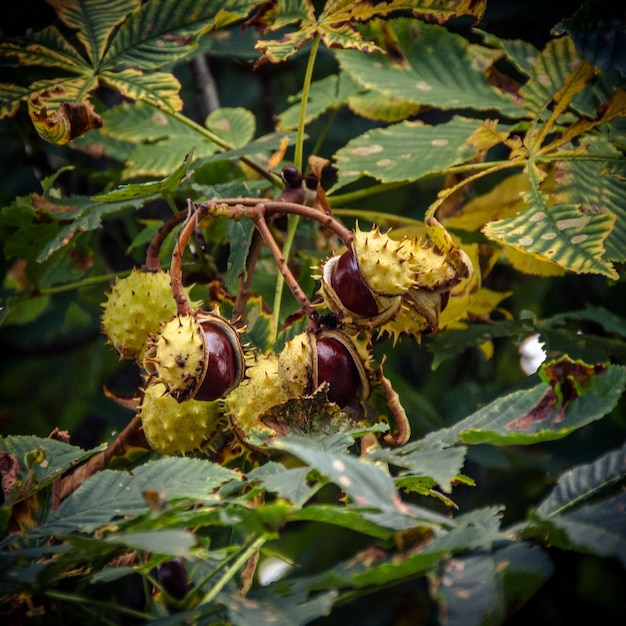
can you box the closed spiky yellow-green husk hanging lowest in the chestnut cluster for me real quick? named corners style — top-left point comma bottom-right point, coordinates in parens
top-left (139, 383), bottom-right (227, 455)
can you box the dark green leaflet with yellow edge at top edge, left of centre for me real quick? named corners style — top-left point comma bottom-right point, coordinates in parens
top-left (102, 0), bottom-right (258, 70)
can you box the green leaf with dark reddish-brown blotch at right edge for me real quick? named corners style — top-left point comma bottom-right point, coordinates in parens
top-left (421, 357), bottom-right (626, 446)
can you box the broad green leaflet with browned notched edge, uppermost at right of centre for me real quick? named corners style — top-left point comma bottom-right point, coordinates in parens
top-left (336, 19), bottom-right (525, 118)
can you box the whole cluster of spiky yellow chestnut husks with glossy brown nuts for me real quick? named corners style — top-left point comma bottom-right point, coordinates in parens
top-left (102, 193), bottom-right (471, 455)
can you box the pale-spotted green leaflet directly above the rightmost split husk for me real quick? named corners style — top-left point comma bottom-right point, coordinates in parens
top-left (333, 117), bottom-right (482, 191)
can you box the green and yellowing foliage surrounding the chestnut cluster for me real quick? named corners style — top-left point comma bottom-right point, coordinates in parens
top-left (0, 0), bottom-right (626, 626)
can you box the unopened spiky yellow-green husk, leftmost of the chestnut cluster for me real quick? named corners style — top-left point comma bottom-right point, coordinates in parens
top-left (102, 268), bottom-right (176, 360)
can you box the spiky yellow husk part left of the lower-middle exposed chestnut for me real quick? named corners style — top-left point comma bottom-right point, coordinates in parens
top-left (224, 353), bottom-right (289, 434)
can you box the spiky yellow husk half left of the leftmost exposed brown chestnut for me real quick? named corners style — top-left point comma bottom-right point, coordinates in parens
top-left (144, 315), bottom-right (206, 402)
